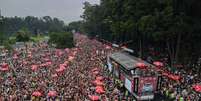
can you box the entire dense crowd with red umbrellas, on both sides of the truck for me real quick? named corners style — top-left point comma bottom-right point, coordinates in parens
top-left (0, 34), bottom-right (201, 101)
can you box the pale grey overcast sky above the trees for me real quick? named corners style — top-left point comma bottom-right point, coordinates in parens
top-left (0, 0), bottom-right (100, 23)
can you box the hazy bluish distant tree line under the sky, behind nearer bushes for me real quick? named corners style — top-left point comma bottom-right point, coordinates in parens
top-left (1, 16), bottom-right (64, 35)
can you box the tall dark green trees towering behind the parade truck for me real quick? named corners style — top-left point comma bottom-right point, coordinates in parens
top-left (74, 0), bottom-right (201, 67)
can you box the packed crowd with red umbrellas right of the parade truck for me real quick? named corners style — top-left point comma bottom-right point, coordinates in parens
top-left (148, 50), bottom-right (201, 101)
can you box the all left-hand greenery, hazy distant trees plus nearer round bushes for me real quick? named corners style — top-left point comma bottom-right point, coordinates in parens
top-left (0, 16), bottom-right (73, 49)
